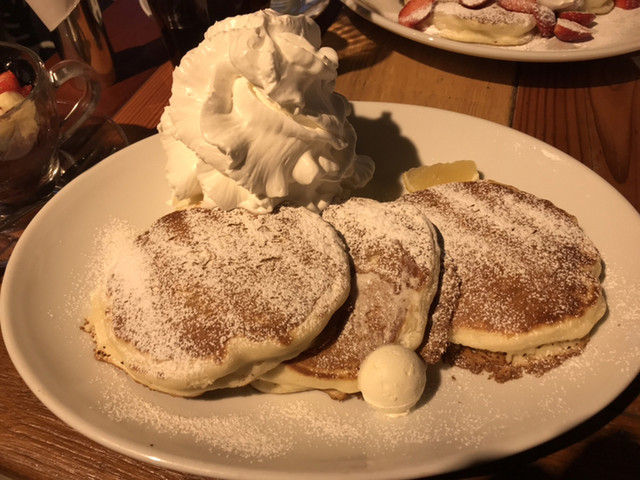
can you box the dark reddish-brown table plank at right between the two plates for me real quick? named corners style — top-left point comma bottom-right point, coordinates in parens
top-left (512, 54), bottom-right (640, 210)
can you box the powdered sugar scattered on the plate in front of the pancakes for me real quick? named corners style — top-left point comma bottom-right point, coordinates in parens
top-left (95, 320), bottom-right (636, 466)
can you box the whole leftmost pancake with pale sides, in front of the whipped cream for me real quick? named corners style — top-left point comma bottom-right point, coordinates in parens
top-left (87, 207), bottom-right (350, 396)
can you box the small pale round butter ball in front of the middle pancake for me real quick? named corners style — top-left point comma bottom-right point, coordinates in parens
top-left (358, 344), bottom-right (427, 416)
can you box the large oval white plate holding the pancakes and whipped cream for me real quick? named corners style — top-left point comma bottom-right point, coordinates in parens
top-left (0, 102), bottom-right (640, 479)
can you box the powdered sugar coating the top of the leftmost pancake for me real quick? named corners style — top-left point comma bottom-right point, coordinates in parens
top-left (108, 209), bottom-right (348, 360)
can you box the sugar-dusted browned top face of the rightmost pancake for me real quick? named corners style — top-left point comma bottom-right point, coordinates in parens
top-left (403, 181), bottom-right (600, 335)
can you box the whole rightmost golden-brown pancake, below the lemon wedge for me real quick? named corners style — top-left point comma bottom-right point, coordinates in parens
top-left (399, 181), bottom-right (606, 381)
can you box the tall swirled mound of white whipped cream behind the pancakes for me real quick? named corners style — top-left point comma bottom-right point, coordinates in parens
top-left (158, 10), bottom-right (374, 213)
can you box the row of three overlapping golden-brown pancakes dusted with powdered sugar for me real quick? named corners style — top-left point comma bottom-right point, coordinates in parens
top-left (87, 181), bottom-right (606, 398)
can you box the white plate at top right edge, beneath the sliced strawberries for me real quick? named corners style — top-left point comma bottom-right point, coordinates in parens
top-left (342, 0), bottom-right (640, 62)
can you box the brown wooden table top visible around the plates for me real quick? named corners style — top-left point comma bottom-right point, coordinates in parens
top-left (0, 0), bottom-right (640, 480)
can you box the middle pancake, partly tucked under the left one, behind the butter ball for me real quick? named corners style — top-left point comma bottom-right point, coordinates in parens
top-left (253, 198), bottom-right (440, 398)
